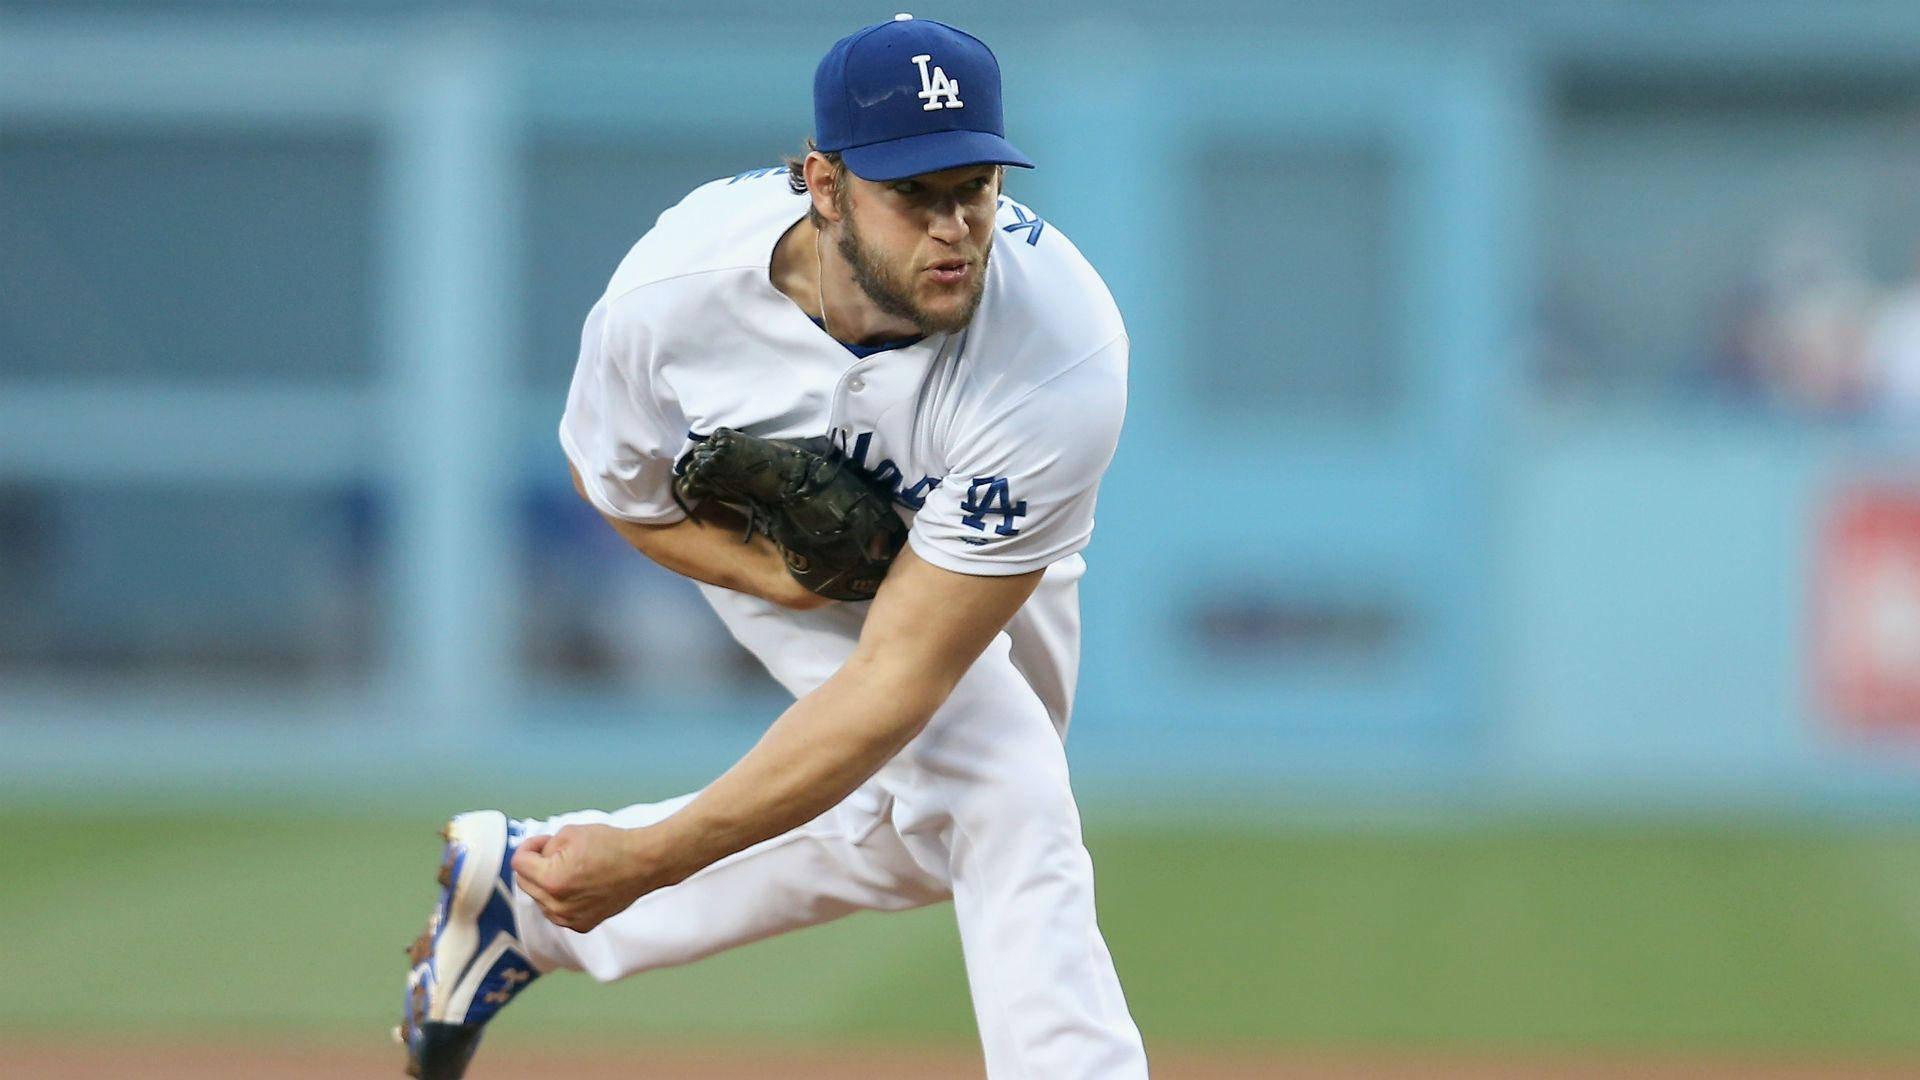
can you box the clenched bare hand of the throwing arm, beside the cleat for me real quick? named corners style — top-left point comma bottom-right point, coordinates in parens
top-left (513, 824), bottom-right (668, 934)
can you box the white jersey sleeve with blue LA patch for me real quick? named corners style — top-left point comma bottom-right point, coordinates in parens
top-left (908, 336), bottom-right (1127, 577)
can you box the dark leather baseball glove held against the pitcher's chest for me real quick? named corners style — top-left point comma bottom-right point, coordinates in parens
top-left (674, 427), bottom-right (906, 600)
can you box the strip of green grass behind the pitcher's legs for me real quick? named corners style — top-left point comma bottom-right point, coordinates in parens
top-left (11, 809), bottom-right (1920, 1057)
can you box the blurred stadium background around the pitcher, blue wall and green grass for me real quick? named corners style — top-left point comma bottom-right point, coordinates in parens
top-left (11, 0), bottom-right (1920, 1076)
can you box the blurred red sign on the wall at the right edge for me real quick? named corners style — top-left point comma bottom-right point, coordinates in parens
top-left (1814, 486), bottom-right (1920, 736)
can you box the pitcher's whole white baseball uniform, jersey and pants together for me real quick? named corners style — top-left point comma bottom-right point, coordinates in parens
top-left (533, 169), bottom-right (1146, 1080)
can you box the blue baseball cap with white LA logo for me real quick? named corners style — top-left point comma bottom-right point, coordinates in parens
top-left (814, 15), bottom-right (1033, 181)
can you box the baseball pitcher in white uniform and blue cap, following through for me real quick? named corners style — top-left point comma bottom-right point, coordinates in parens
top-left (399, 15), bottom-right (1146, 1080)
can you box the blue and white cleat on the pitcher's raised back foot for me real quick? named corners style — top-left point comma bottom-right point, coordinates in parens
top-left (394, 811), bottom-right (540, 1080)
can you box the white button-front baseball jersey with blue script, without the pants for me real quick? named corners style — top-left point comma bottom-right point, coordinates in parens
top-left (561, 169), bottom-right (1127, 728)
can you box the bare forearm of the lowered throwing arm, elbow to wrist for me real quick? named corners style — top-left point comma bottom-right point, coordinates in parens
top-left (643, 655), bottom-right (936, 882)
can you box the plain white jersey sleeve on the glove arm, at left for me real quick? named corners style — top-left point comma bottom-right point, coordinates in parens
top-left (561, 300), bottom-right (685, 525)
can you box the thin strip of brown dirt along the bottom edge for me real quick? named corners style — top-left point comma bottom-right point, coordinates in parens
top-left (15, 1045), bottom-right (1916, 1080)
